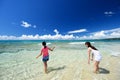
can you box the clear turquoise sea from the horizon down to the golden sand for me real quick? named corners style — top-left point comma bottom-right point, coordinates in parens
top-left (0, 40), bottom-right (120, 80)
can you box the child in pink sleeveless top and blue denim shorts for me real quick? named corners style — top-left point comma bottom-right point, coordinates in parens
top-left (36, 42), bottom-right (55, 73)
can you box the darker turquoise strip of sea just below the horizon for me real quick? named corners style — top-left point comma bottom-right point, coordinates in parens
top-left (0, 40), bottom-right (120, 54)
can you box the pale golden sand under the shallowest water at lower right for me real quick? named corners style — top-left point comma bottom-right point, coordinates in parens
top-left (35, 56), bottom-right (120, 80)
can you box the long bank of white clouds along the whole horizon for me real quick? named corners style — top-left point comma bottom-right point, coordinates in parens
top-left (0, 28), bottom-right (120, 40)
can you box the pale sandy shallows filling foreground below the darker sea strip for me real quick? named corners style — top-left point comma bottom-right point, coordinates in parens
top-left (0, 42), bottom-right (120, 80)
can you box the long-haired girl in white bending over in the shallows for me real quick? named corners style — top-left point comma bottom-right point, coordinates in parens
top-left (85, 42), bottom-right (102, 73)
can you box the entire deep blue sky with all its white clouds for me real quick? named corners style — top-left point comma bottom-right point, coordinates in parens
top-left (0, 0), bottom-right (120, 40)
